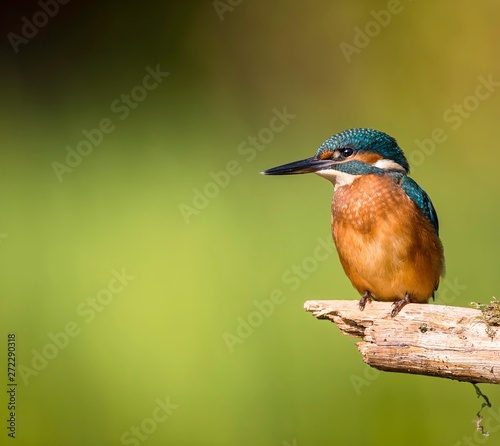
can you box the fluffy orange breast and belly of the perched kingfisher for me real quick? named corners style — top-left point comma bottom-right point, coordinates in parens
top-left (332, 175), bottom-right (444, 302)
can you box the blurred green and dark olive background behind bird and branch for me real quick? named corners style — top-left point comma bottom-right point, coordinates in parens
top-left (0, 0), bottom-right (500, 446)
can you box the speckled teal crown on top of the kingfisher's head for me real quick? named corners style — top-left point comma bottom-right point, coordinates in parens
top-left (315, 128), bottom-right (410, 173)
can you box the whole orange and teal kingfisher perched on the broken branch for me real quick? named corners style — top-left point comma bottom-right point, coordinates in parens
top-left (261, 128), bottom-right (445, 317)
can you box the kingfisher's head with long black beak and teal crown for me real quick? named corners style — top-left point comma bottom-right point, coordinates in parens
top-left (262, 128), bottom-right (410, 186)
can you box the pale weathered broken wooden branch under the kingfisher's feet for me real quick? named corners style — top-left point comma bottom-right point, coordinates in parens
top-left (304, 300), bottom-right (500, 384)
